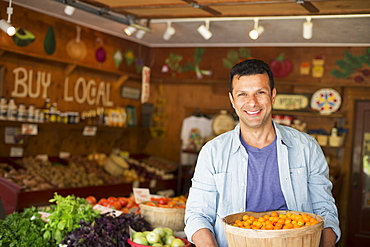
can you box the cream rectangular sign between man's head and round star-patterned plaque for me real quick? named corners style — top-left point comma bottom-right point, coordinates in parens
top-left (273, 94), bottom-right (309, 110)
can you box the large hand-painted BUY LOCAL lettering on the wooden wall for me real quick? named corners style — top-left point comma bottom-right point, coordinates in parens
top-left (11, 67), bottom-right (113, 107)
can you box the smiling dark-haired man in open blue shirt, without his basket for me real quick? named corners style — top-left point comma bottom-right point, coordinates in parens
top-left (185, 59), bottom-right (340, 247)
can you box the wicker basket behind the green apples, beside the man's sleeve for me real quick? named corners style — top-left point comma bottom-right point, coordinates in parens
top-left (140, 203), bottom-right (185, 231)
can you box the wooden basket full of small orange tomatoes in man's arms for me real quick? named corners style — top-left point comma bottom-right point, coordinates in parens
top-left (223, 210), bottom-right (324, 247)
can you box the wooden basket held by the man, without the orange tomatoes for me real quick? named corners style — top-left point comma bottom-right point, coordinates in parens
top-left (223, 210), bottom-right (324, 247)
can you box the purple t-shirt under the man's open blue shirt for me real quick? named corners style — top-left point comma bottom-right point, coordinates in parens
top-left (240, 137), bottom-right (288, 212)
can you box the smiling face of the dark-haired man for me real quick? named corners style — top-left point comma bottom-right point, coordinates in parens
top-left (229, 74), bottom-right (276, 129)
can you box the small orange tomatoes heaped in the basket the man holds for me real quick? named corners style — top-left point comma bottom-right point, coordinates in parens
top-left (231, 212), bottom-right (319, 230)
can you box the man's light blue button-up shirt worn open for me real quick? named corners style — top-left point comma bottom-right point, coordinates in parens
top-left (185, 123), bottom-right (341, 247)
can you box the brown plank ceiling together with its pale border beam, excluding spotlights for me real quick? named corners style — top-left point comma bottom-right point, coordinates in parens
top-left (10, 0), bottom-right (370, 47)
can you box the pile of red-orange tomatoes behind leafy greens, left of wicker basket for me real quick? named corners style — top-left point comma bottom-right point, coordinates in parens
top-left (86, 196), bottom-right (139, 213)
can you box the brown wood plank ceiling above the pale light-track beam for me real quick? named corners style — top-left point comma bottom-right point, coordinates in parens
top-left (81, 0), bottom-right (370, 19)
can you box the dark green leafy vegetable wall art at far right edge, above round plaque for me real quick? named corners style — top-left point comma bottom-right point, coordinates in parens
top-left (330, 48), bottom-right (370, 82)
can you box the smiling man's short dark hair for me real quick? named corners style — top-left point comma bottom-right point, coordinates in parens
top-left (229, 59), bottom-right (275, 94)
